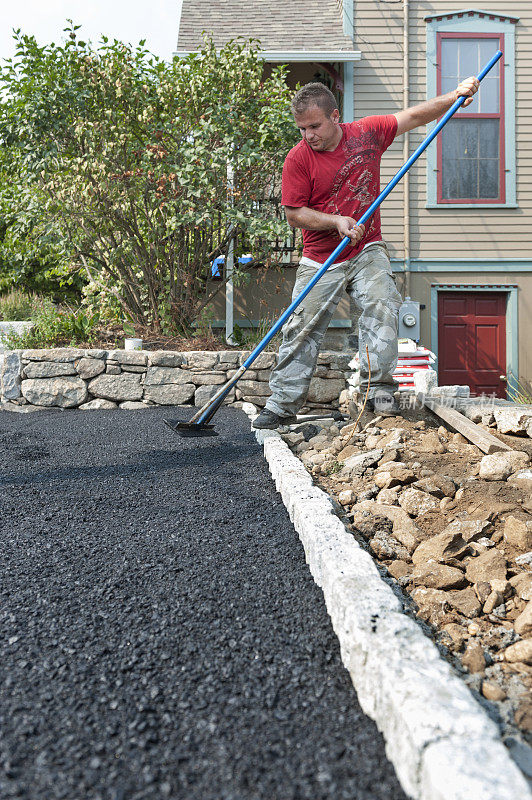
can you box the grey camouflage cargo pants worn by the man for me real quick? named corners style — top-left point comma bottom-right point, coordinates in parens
top-left (266, 242), bottom-right (402, 416)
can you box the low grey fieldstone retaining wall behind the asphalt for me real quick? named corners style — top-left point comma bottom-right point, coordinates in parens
top-left (0, 348), bottom-right (351, 411)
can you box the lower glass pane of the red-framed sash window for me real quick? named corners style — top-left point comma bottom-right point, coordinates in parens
top-left (441, 119), bottom-right (499, 202)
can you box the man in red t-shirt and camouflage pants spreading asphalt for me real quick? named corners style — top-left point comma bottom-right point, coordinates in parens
top-left (253, 77), bottom-right (478, 428)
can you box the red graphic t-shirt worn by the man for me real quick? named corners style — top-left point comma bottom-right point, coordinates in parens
top-left (282, 114), bottom-right (397, 263)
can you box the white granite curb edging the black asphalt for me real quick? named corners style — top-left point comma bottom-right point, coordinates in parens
top-left (243, 403), bottom-right (532, 800)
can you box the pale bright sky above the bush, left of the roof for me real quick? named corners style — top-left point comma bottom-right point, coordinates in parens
top-left (0, 0), bottom-right (181, 59)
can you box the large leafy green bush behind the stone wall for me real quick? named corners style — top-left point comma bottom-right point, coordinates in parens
top-left (0, 26), bottom-right (297, 332)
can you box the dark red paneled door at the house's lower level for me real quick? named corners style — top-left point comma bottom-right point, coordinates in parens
top-left (438, 291), bottom-right (506, 397)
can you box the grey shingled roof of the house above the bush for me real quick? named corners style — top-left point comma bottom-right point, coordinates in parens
top-left (177, 0), bottom-right (353, 51)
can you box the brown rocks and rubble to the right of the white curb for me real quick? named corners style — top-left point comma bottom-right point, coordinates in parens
top-left (282, 409), bottom-right (532, 771)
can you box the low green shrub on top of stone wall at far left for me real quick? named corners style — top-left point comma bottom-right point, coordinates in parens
top-left (4, 298), bottom-right (100, 350)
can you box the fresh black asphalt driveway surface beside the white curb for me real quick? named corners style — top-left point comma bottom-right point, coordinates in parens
top-left (0, 408), bottom-right (406, 800)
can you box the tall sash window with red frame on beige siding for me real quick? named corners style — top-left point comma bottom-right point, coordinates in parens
top-left (438, 33), bottom-right (505, 205)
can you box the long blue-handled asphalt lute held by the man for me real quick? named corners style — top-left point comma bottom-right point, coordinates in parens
top-left (165, 50), bottom-right (502, 436)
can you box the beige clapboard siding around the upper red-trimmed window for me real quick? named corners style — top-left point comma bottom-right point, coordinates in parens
top-left (355, 0), bottom-right (532, 259)
